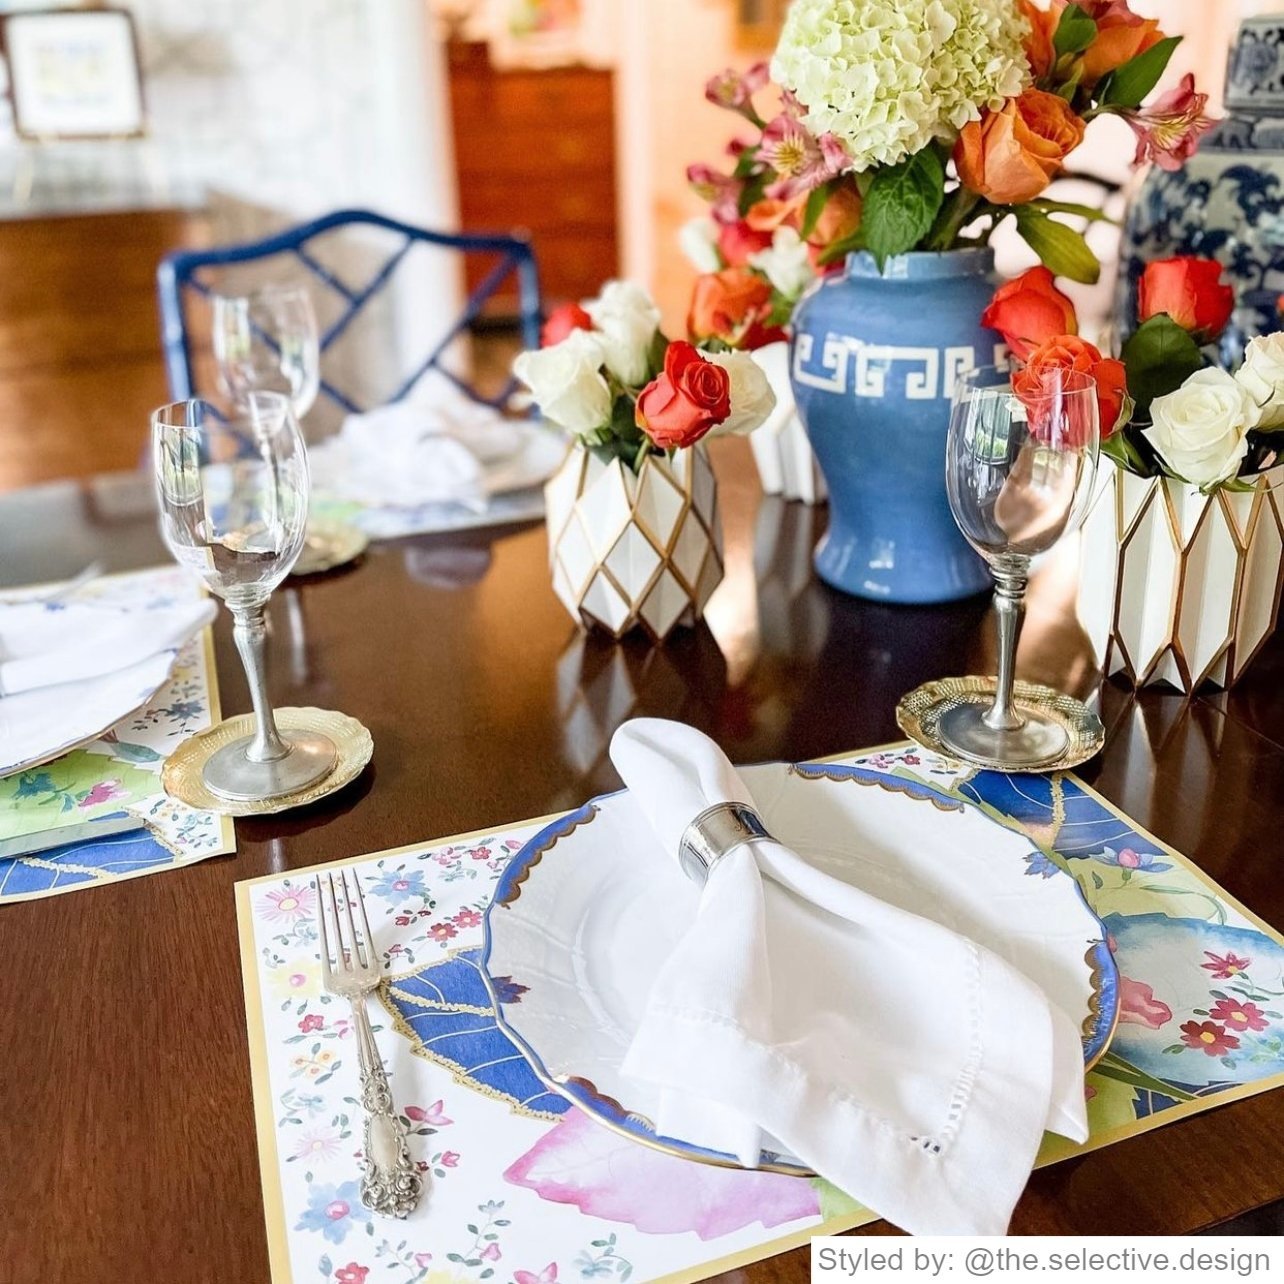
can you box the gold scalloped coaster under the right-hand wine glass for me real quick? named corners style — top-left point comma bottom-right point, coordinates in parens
top-left (896, 678), bottom-right (1106, 776)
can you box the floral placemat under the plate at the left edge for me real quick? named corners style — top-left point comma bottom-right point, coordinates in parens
top-left (0, 566), bottom-right (235, 903)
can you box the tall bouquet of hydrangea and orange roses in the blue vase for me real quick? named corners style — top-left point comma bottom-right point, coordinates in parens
top-left (684, 0), bottom-right (1215, 291)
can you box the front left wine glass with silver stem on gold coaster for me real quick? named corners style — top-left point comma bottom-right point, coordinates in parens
top-left (152, 392), bottom-right (338, 801)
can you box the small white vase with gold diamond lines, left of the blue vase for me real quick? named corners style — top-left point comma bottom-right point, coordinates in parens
top-left (544, 446), bottom-right (723, 642)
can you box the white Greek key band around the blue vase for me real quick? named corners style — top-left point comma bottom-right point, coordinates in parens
top-left (794, 334), bottom-right (1007, 401)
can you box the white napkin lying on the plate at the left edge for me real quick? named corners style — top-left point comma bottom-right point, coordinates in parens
top-left (0, 598), bottom-right (217, 696)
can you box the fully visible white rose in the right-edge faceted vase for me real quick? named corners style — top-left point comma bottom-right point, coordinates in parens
top-left (1145, 370), bottom-right (1257, 487)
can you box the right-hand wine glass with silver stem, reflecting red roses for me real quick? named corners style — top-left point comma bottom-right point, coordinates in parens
top-left (937, 366), bottom-right (1100, 769)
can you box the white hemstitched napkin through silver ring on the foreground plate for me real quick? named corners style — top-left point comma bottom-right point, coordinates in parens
top-left (611, 719), bottom-right (1088, 1235)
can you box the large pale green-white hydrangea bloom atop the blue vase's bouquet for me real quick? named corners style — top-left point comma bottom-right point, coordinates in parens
top-left (772, 0), bottom-right (1030, 171)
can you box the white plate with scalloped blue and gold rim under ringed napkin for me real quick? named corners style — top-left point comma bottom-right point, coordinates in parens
top-left (482, 764), bottom-right (1118, 1175)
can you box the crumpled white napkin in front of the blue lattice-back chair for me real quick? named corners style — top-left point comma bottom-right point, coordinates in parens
top-left (308, 393), bottom-right (523, 508)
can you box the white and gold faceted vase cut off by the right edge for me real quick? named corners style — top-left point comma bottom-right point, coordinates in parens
top-left (1079, 461), bottom-right (1284, 695)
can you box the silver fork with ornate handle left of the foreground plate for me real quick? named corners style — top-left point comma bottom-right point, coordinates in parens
top-left (315, 872), bottom-right (424, 1217)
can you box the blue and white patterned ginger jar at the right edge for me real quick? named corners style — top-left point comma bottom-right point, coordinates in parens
top-left (1116, 14), bottom-right (1284, 366)
